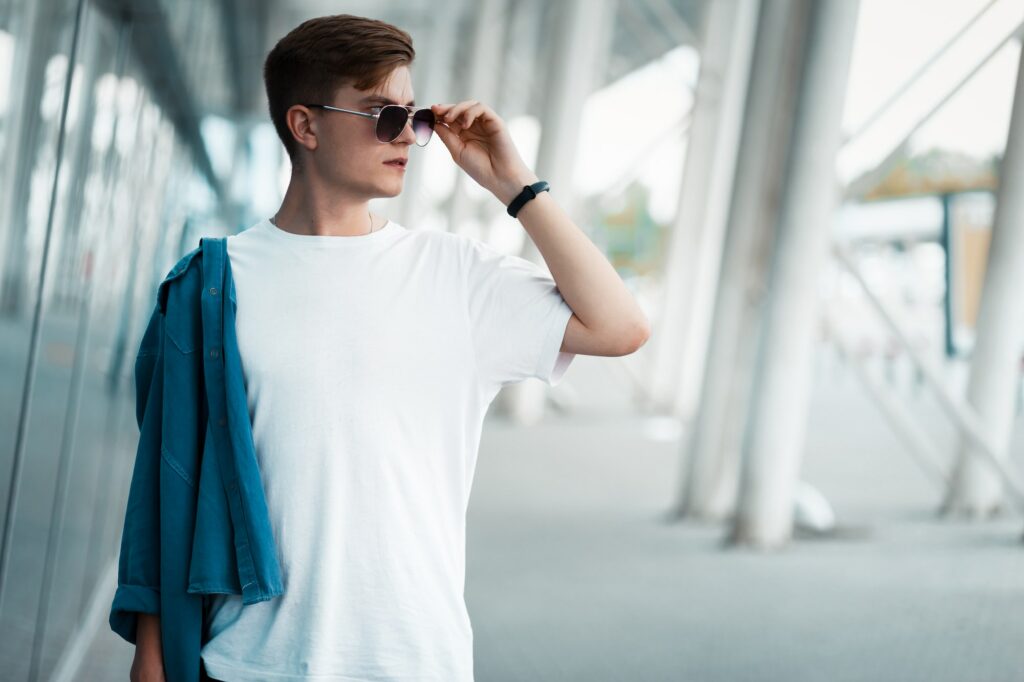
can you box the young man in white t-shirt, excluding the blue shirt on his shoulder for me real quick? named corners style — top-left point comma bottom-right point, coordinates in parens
top-left (133, 14), bottom-right (648, 682)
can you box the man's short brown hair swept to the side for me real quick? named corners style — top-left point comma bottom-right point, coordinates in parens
top-left (263, 14), bottom-right (416, 165)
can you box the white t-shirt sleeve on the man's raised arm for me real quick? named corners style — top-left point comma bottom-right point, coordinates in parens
top-left (466, 238), bottom-right (575, 386)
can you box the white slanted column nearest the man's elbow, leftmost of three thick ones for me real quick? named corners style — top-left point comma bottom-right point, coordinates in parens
top-left (648, 0), bottom-right (760, 421)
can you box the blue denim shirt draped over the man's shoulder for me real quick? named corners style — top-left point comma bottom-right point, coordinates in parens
top-left (110, 238), bottom-right (284, 682)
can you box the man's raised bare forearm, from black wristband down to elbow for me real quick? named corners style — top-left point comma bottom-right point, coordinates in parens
top-left (497, 174), bottom-right (650, 343)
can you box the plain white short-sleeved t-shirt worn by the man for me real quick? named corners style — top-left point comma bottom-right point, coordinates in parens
top-left (202, 215), bottom-right (574, 682)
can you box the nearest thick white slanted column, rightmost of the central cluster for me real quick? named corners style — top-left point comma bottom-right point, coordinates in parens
top-left (729, 0), bottom-right (859, 547)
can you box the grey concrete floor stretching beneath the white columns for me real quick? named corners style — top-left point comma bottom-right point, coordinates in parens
top-left (41, 348), bottom-right (1024, 682)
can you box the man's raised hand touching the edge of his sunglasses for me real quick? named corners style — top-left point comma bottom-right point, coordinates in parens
top-left (430, 99), bottom-right (538, 205)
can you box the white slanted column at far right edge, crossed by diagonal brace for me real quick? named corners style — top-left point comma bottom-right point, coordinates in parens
top-left (941, 42), bottom-right (1024, 517)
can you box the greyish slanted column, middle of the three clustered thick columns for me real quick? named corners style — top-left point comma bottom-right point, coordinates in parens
top-left (677, 0), bottom-right (803, 520)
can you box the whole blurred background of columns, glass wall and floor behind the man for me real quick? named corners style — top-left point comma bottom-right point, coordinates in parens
top-left (0, 0), bottom-right (1024, 682)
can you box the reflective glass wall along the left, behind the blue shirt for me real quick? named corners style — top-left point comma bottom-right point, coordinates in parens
top-left (0, 0), bottom-right (226, 681)
